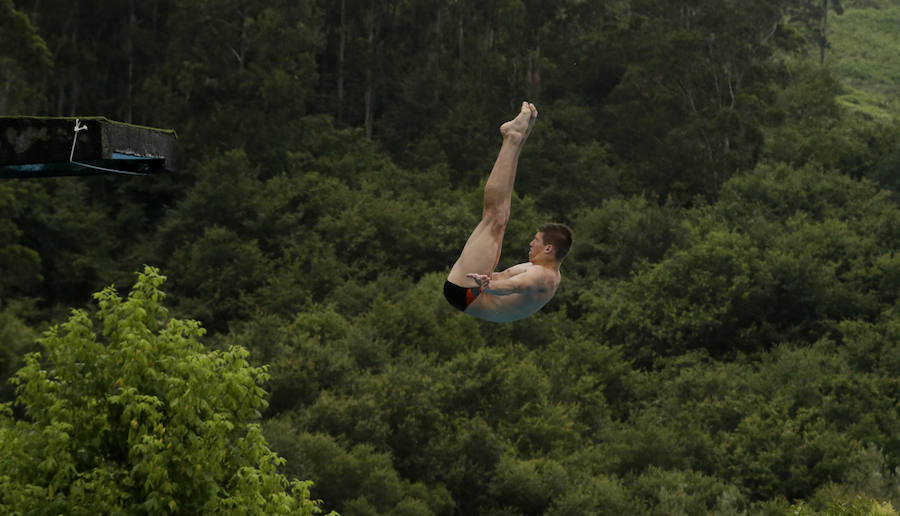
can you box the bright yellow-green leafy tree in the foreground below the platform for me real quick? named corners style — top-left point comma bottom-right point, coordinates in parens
top-left (0, 267), bottom-right (330, 515)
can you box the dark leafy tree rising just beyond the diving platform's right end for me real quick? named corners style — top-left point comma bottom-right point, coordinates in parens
top-left (155, 0), bottom-right (321, 165)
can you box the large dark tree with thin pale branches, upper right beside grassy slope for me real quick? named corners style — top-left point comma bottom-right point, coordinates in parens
top-left (606, 0), bottom-right (795, 199)
